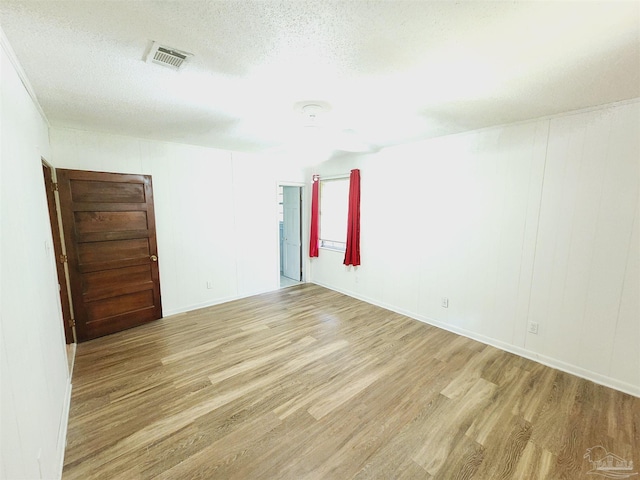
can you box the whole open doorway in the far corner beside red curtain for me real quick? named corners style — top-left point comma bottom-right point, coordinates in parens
top-left (278, 185), bottom-right (302, 288)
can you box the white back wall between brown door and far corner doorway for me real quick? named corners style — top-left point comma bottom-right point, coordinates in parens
top-left (50, 128), bottom-right (303, 316)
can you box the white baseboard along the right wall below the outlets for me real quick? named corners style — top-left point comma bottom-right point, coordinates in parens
top-left (311, 281), bottom-right (640, 398)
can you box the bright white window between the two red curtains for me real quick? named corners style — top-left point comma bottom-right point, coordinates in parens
top-left (320, 178), bottom-right (349, 252)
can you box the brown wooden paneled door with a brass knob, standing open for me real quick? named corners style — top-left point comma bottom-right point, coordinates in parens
top-left (57, 170), bottom-right (162, 342)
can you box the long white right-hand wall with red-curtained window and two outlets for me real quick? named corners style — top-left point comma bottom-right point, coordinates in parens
top-left (308, 101), bottom-right (640, 396)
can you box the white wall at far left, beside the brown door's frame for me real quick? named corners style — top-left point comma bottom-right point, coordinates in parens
top-left (0, 38), bottom-right (71, 479)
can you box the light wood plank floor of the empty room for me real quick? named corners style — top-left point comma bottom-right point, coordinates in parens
top-left (63, 285), bottom-right (640, 480)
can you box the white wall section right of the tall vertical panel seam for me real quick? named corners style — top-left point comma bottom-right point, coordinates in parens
top-left (525, 104), bottom-right (640, 389)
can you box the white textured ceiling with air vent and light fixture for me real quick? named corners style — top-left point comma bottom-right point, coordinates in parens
top-left (0, 0), bottom-right (640, 159)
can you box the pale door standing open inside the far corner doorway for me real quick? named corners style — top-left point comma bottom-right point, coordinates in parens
top-left (282, 186), bottom-right (302, 281)
